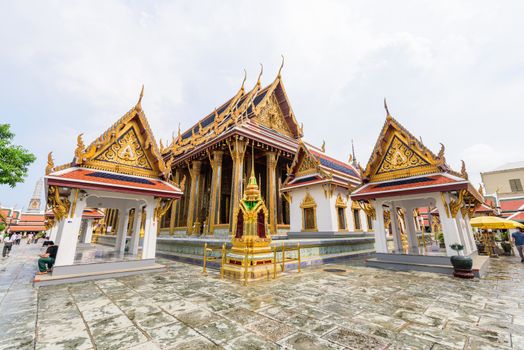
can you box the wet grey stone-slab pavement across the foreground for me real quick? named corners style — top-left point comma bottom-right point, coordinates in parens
top-left (0, 241), bottom-right (524, 350)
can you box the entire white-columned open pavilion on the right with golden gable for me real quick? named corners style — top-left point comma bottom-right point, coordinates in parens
top-left (351, 107), bottom-right (485, 275)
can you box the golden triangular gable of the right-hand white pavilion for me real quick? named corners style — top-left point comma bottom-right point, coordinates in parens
top-left (363, 113), bottom-right (448, 182)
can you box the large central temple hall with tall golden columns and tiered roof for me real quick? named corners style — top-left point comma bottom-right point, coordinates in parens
top-left (160, 66), bottom-right (302, 237)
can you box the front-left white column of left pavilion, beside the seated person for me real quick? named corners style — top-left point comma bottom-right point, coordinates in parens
top-left (55, 196), bottom-right (86, 266)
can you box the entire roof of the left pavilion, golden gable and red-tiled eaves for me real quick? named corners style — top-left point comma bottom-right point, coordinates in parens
top-left (45, 88), bottom-right (182, 198)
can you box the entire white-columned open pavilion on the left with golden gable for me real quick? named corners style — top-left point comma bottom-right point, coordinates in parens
top-left (35, 90), bottom-right (182, 285)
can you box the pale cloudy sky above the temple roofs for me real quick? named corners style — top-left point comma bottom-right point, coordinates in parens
top-left (0, 0), bottom-right (524, 208)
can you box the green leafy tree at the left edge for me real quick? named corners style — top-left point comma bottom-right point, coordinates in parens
top-left (0, 124), bottom-right (36, 187)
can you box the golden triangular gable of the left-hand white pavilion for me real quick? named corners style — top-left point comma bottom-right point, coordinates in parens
top-left (74, 89), bottom-right (171, 179)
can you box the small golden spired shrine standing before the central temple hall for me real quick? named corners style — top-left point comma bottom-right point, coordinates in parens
top-left (223, 148), bottom-right (274, 280)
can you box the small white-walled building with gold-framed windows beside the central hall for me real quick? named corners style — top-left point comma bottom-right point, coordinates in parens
top-left (281, 140), bottom-right (366, 237)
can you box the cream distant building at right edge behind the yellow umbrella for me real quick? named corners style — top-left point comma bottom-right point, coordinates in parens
top-left (480, 161), bottom-right (524, 222)
